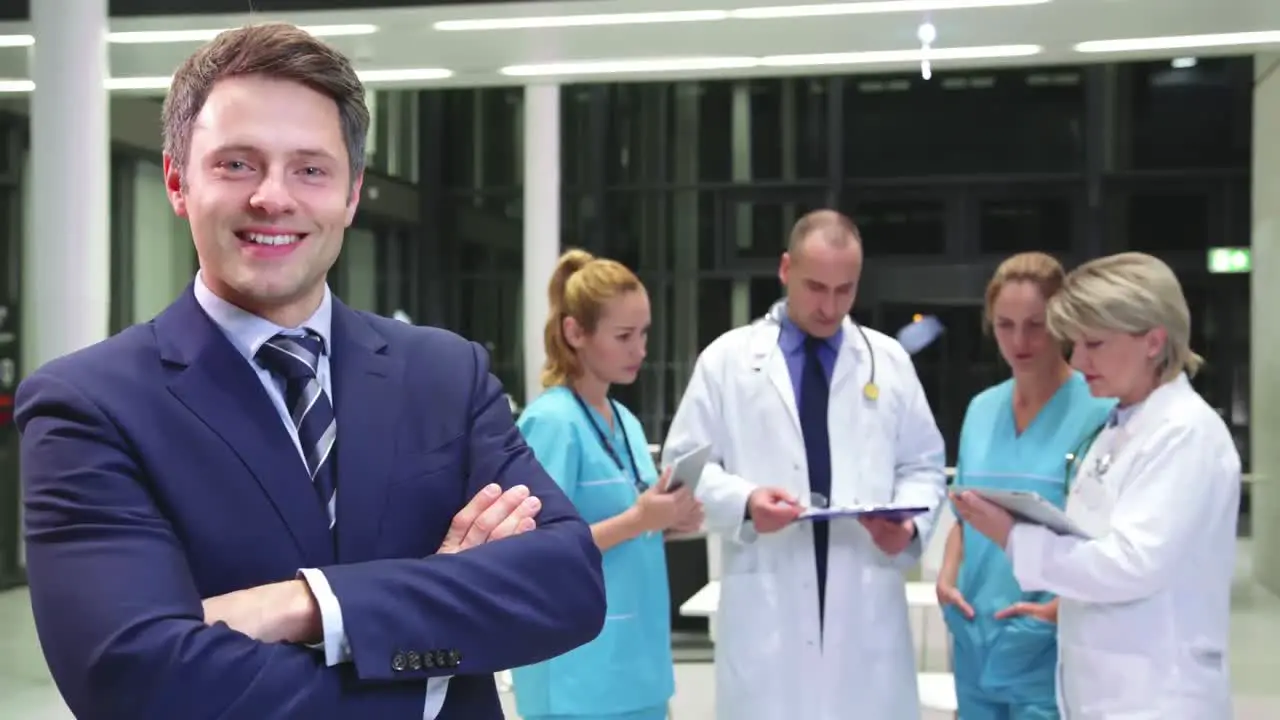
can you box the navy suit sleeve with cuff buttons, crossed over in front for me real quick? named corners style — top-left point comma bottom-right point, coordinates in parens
top-left (314, 343), bottom-right (605, 680)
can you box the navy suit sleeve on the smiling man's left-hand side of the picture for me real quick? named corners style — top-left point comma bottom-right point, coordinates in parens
top-left (17, 370), bottom-right (425, 720)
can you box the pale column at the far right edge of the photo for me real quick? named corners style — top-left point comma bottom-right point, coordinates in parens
top-left (1249, 54), bottom-right (1280, 593)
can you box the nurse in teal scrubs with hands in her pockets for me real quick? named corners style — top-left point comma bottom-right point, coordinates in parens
top-left (938, 252), bottom-right (1114, 720)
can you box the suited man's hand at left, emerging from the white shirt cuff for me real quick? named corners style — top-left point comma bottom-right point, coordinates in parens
top-left (204, 579), bottom-right (324, 643)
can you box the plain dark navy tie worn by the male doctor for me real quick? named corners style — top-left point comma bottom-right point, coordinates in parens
top-left (800, 337), bottom-right (831, 624)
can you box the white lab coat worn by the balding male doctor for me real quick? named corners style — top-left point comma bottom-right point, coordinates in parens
top-left (663, 315), bottom-right (946, 720)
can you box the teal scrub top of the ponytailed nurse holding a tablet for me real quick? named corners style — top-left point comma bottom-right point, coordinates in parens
top-left (512, 387), bottom-right (676, 717)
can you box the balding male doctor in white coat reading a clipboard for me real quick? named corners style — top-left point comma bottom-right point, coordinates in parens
top-left (663, 210), bottom-right (946, 720)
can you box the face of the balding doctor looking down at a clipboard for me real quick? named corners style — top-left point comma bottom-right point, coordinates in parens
top-left (778, 237), bottom-right (863, 337)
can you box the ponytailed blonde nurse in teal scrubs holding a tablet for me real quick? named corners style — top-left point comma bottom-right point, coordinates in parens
top-left (512, 250), bottom-right (703, 720)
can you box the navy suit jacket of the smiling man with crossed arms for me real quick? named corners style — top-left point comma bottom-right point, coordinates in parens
top-left (17, 288), bottom-right (605, 720)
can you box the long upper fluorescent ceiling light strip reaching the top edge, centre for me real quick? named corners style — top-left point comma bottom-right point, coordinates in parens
top-left (431, 0), bottom-right (1053, 32)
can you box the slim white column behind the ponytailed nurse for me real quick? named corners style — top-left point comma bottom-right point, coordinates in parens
top-left (521, 85), bottom-right (561, 405)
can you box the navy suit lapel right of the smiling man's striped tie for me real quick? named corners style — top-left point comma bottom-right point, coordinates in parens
top-left (330, 300), bottom-right (404, 562)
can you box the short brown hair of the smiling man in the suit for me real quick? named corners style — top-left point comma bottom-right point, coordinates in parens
top-left (161, 23), bottom-right (369, 182)
